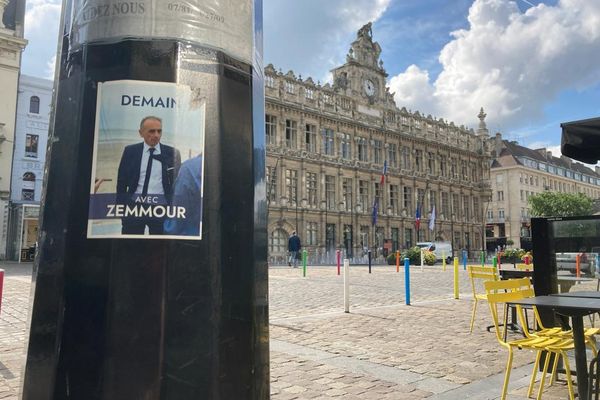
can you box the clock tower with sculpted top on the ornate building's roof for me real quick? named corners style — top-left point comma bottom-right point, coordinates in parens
top-left (331, 22), bottom-right (395, 106)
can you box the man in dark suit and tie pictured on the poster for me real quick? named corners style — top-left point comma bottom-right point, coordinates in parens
top-left (117, 116), bottom-right (181, 235)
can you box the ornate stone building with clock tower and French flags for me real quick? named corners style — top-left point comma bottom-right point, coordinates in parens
top-left (265, 24), bottom-right (490, 262)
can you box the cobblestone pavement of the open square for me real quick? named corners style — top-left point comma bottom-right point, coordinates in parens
top-left (0, 265), bottom-right (595, 400)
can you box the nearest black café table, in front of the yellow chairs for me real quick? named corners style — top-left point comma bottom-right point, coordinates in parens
top-left (507, 292), bottom-right (600, 399)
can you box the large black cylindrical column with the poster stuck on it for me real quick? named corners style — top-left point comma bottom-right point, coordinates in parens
top-left (22, 0), bottom-right (269, 400)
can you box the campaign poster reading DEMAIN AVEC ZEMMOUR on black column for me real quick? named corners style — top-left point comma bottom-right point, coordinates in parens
top-left (87, 80), bottom-right (205, 240)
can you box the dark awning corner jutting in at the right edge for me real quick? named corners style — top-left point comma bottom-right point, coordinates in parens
top-left (560, 118), bottom-right (600, 164)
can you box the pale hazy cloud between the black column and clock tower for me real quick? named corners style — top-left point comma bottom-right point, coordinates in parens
top-left (264, 0), bottom-right (391, 81)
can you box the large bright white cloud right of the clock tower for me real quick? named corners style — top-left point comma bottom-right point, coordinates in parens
top-left (390, 0), bottom-right (600, 129)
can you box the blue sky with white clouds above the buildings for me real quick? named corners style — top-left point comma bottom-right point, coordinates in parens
top-left (22, 0), bottom-right (600, 162)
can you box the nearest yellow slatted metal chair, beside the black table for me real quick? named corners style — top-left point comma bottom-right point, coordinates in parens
top-left (484, 278), bottom-right (575, 400)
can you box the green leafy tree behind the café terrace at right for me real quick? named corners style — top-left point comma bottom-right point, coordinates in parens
top-left (528, 192), bottom-right (593, 217)
